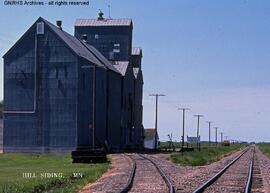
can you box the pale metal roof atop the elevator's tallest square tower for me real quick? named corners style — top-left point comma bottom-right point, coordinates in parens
top-left (75, 18), bottom-right (132, 27)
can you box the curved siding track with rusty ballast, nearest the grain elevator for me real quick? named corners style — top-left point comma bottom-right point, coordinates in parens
top-left (119, 154), bottom-right (175, 193)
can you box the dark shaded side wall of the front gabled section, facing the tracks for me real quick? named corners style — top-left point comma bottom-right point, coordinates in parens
top-left (77, 60), bottom-right (108, 147)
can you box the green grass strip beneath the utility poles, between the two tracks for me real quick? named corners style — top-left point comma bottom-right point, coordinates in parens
top-left (170, 144), bottom-right (244, 166)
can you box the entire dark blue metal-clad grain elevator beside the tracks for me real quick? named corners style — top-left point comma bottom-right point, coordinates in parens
top-left (3, 14), bottom-right (144, 152)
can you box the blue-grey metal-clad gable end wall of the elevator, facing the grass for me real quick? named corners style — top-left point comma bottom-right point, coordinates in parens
top-left (4, 21), bottom-right (77, 152)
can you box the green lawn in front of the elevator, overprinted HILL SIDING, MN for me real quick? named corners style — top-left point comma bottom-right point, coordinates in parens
top-left (0, 153), bottom-right (109, 193)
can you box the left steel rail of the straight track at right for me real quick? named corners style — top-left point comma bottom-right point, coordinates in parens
top-left (193, 147), bottom-right (250, 193)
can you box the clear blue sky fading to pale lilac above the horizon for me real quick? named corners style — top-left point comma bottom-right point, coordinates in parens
top-left (0, 0), bottom-right (270, 141)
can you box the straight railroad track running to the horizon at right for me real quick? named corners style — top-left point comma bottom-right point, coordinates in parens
top-left (193, 147), bottom-right (255, 193)
